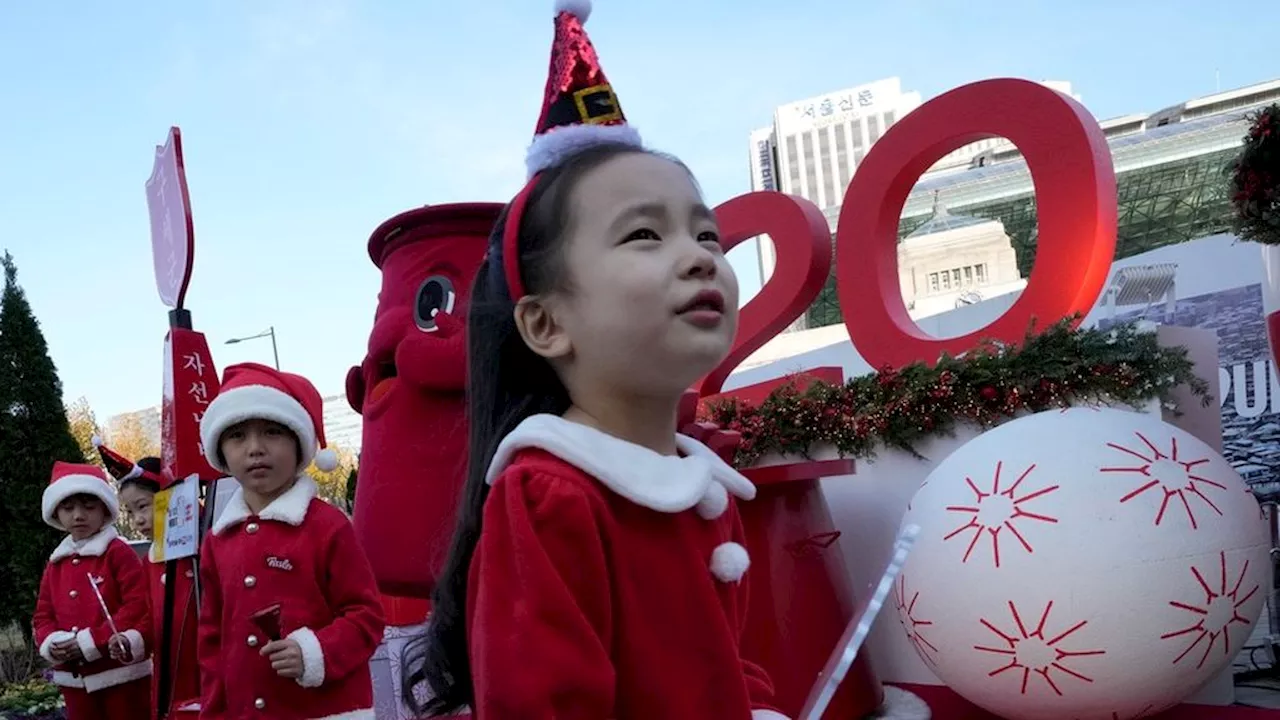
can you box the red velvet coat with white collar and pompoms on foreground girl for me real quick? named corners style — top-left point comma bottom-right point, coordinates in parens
top-left (467, 415), bottom-right (781, 720)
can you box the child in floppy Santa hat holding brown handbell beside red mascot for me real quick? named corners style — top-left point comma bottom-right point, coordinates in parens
top-left (200, 363), bottom-right (383, 720)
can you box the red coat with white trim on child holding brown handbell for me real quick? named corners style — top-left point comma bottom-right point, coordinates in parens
top-left (198, 475), bottom-right (383, 720)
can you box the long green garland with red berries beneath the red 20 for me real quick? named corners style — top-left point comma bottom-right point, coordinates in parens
top-left (701, 318), bottom-right (1211, 468)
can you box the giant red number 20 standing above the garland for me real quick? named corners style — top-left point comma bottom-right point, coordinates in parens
top-left (699, 79), bottom-right (1116, 397)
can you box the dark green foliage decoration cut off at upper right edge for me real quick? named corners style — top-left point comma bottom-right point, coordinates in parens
top-left (1229, 105), bottom-right (1280, 245)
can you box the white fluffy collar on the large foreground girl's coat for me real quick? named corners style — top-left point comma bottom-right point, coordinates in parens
top-left (485, 415), bottom-right (755, 512)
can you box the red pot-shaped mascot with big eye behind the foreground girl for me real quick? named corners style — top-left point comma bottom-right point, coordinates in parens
top-left (347, 202), bottom-right (502, 624)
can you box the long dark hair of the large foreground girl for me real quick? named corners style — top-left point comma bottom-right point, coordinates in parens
top-left (402, 143), bottom-right (648, 714)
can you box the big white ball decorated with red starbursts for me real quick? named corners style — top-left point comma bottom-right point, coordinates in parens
top-left (896, 407), bottom-right (1271, 720)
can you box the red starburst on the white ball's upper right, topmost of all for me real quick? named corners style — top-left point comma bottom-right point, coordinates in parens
top-left (1102, 432), bottom-right (1226, 530)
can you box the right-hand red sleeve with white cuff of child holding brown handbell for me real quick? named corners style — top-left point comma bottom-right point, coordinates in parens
top-left (289, 509), bottom-right (385, 688)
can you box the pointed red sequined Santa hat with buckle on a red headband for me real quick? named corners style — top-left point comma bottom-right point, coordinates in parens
top-left (502, 0), bottom-right (644, 300)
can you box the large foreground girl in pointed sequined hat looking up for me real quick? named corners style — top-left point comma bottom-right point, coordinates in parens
top-left (407, 1), bottom-right (781, 720)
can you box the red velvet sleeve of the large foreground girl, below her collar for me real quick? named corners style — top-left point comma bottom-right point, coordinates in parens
top-left (467, 465), bottom-right (616, 720)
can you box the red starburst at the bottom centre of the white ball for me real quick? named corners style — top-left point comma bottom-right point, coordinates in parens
top-left (973, 601), bottom-right (1106, 697)
